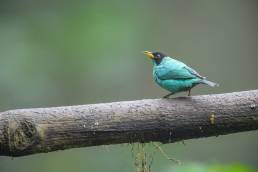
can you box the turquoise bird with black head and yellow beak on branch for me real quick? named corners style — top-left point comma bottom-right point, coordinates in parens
top-left (143, 51), bottom-right (219, 98)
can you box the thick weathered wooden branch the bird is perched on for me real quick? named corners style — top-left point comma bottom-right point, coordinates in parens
top-left (0, 90), bottom-right (258, 156)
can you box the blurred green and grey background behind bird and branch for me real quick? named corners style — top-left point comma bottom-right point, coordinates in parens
top-left (0, 0), bottom-right (258, 172)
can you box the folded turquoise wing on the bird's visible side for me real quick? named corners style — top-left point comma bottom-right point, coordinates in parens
top-left (155, 59), bottom-right (204, 80)
